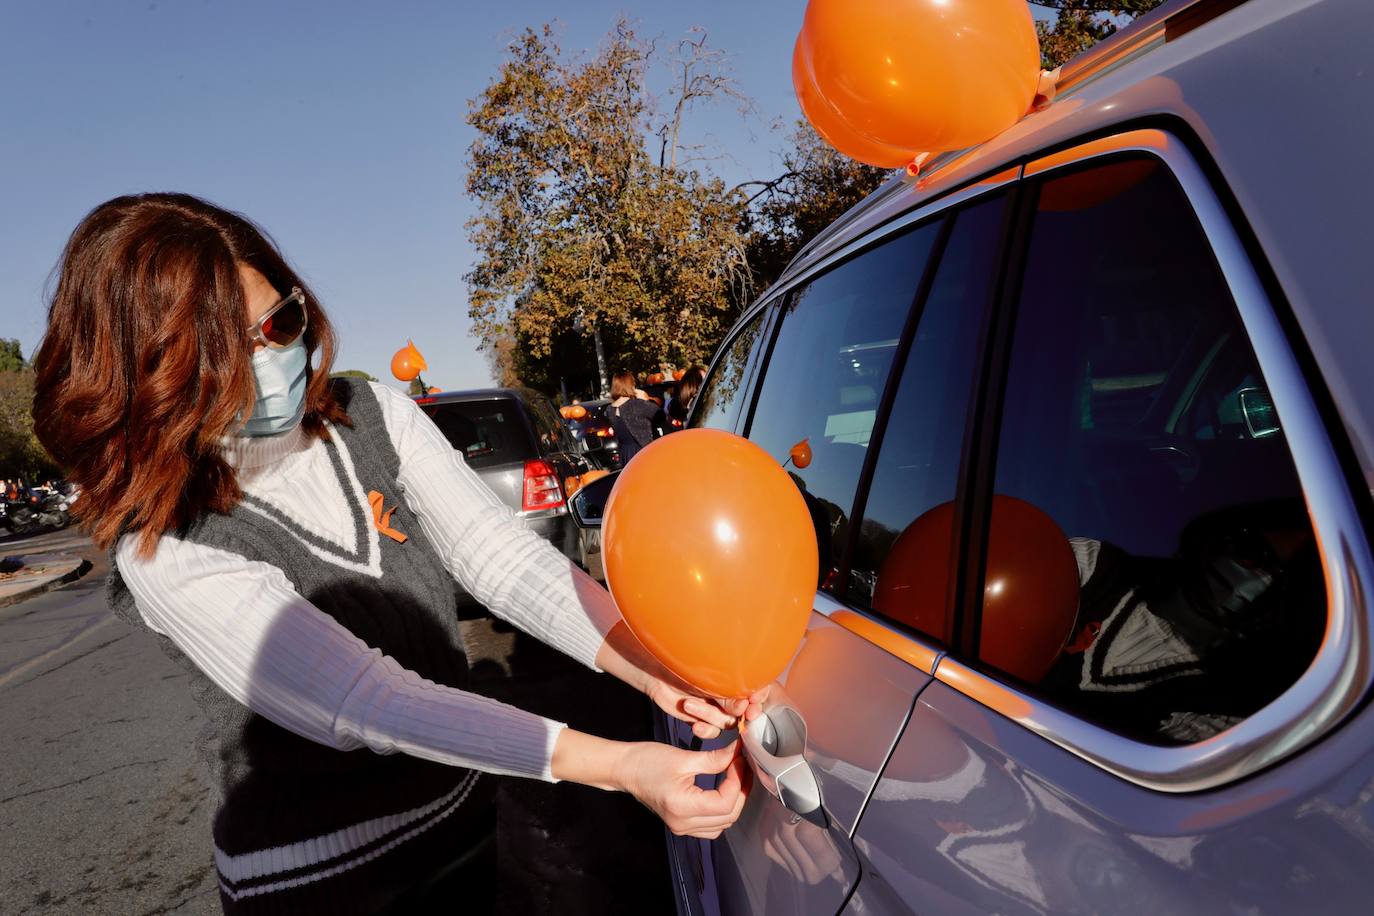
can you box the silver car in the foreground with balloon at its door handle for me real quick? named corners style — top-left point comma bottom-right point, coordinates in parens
top-left (574, 0), bottom-right (1374, 915)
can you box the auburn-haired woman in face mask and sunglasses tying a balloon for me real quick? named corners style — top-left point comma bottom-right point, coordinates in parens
top-left (34, 194), bottom-right (743, 912)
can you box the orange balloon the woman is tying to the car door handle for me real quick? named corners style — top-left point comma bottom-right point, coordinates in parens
top-left (604, 430), bottom-right (819, 696)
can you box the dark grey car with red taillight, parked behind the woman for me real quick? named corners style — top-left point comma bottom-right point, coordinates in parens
top-left (415, 389), bottom-right (594, 598)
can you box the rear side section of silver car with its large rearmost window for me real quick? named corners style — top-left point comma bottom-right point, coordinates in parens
top-left (846, 130), bottom-right (1374, 913)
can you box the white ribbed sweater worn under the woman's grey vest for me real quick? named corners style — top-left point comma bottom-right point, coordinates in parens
top-left (115, 385), bottom-right (620, 780)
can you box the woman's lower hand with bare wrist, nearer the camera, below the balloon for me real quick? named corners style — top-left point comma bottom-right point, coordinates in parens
top-left (550, 728), bottom-right (749, 839)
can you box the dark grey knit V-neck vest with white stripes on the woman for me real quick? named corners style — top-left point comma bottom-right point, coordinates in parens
top-left (107, 379), bottom-right (489, 912)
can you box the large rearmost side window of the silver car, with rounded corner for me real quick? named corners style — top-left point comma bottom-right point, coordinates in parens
top-left (978, 158), bottom-right (1326, 744)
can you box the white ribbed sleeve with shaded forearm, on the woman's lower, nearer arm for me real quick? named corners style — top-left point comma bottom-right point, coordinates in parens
top-left (115, 536), bottom-right (563, 780)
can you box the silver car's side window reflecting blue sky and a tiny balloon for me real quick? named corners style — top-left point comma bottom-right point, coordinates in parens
top-left (749, 224), bottom-right (940, 587)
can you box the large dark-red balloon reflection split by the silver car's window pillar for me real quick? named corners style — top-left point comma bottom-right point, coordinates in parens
top-left (872, 496), bottom-right (1079, 684)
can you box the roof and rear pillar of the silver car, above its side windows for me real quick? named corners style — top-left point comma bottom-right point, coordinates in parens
top-left (745, 0), bottom-right (1374, 482)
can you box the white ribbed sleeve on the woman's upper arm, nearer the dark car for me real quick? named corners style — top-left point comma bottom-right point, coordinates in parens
top-left (372, 385), bottom-right (620, 667)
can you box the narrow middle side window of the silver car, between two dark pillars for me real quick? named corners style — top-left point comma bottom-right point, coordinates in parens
top-left (845, 196), bottom-right (1006, 641)
